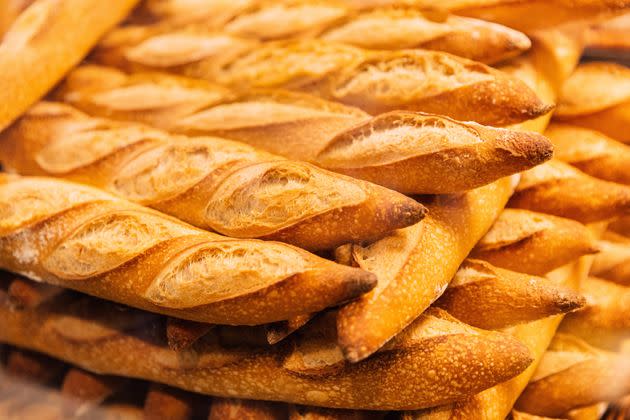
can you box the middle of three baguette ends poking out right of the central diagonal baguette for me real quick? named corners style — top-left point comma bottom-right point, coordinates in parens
top-left (470, 209), bottom-right (599, 276)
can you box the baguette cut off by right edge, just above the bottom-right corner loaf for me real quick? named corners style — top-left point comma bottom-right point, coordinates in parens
top-left (560, 277), bottom-right (630, 351)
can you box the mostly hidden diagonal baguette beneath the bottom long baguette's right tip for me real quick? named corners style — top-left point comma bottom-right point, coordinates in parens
top-left (405, 256), bottom-right (592, 420)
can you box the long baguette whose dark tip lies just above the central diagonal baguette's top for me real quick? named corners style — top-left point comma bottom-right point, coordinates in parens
top-left (56, 66), bottom-right (552, 194)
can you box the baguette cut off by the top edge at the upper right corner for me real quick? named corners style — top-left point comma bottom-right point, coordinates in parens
top-left (348, 0), bottom-right (630, 32)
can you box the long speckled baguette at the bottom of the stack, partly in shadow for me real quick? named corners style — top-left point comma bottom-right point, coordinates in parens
top-left (0, 278), bottom-right (531, 410)
